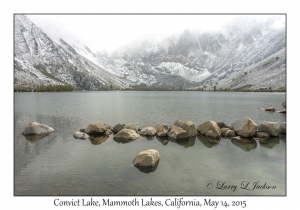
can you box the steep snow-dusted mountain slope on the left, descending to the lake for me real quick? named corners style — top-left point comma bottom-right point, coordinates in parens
top-left (14, 15), bottom-right (130, 90)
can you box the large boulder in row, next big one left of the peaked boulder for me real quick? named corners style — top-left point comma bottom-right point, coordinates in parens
top-left (197, 121), bottom-right (222, 139)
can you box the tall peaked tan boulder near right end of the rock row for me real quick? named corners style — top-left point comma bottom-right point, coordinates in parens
top-left (232, 117), bottom-right (257, 138)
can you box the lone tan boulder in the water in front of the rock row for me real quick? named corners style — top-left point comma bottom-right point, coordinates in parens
top-left (133, 149), bottom-right (160, 167)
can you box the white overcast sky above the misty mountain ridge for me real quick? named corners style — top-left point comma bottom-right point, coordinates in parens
top-left (26, 15), bottom-right (286, 52)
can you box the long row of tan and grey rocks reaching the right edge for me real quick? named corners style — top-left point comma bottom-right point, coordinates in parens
top-left (73, 117), bottom-right (286, 148)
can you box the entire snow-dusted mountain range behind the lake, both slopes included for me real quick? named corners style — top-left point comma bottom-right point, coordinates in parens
top-left (15, 15), bottom-right (286, 90)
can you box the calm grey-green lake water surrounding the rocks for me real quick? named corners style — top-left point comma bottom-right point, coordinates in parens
top-left (14, 91), bottom-right (286, 196)
